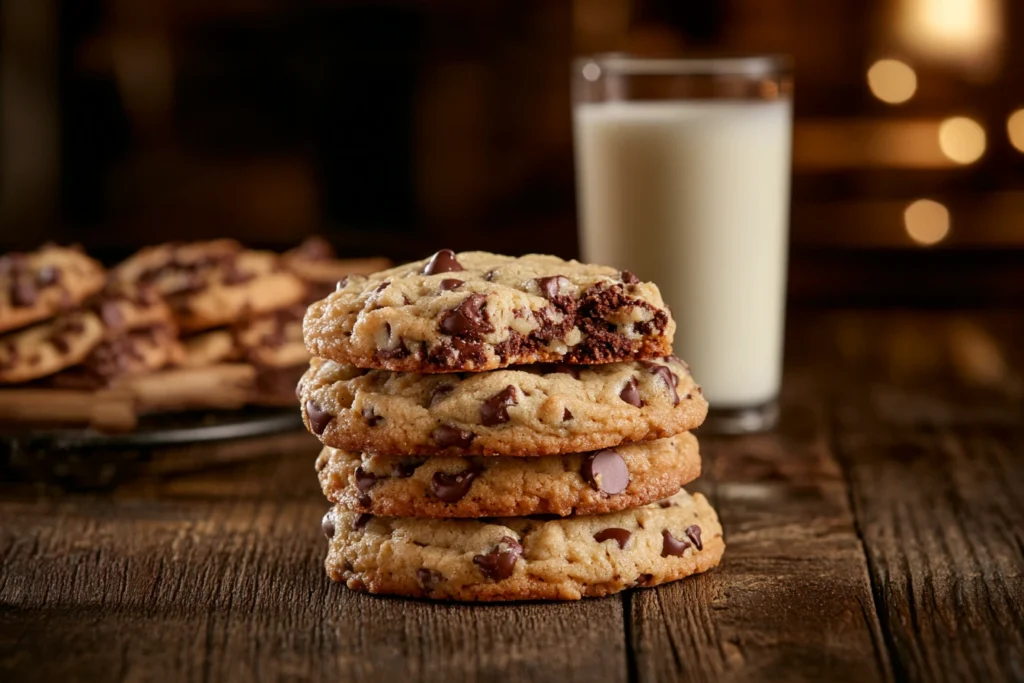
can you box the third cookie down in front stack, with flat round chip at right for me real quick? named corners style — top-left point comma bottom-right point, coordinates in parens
top-left (316, 433), bottom-right (700, 517)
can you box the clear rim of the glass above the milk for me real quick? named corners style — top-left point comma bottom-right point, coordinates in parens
top-left (572, 52), bottom-right (793, 78)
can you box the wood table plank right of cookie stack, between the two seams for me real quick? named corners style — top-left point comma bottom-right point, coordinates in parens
top-left (630, 375), bottom-right (890, 682)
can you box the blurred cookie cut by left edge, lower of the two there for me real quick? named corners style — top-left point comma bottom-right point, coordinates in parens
top-left (0, 310), bottom-right (105, 384)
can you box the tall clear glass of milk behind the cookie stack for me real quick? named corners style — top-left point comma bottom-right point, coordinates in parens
top-left (572, 54), bottom-right (793, 433)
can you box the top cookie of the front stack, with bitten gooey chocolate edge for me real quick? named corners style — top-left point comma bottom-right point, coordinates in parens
top-left (304, 249), bottom-right (676, 373)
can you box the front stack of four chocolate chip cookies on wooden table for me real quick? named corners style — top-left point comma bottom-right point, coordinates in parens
top-left (298, 250), bottom-right (725, 600)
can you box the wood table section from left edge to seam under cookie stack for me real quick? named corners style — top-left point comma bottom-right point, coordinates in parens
top-left (0, 446), bottom-right (628, 682)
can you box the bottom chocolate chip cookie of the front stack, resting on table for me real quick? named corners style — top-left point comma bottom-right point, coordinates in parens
top-left (323, 490), bottom-right (725, 601)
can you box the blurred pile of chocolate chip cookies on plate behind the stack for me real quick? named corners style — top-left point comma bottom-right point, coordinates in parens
top-left (0, 238), bottom-right (388, 431)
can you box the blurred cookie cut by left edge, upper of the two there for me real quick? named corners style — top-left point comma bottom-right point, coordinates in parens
top-left (0, 245), bottom-right (105, 332)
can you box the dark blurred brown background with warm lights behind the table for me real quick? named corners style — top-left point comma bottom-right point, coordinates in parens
top-left (0, 0), bottom-right (1024, 307)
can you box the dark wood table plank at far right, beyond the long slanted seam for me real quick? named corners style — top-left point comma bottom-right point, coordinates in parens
top-left (835, 313), bottom-right (1024, 682)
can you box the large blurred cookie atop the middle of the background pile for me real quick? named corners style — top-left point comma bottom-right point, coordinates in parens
top-left (113, 240), bottom-right (305, 332)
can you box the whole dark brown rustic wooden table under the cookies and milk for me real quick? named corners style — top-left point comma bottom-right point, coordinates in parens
top-left (0, 311), bottom-right (1024, 683)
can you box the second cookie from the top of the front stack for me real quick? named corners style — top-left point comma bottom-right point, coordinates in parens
top-left (298, 356), bottom-right (708, 456)
